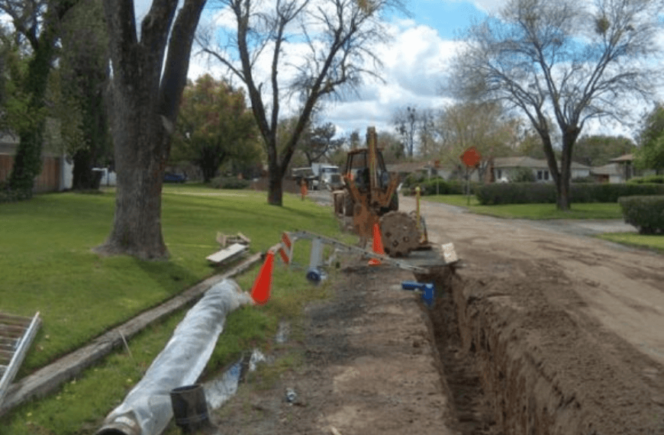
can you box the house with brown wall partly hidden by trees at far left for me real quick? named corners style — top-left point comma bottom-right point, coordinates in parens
top-left (0, 132), bottom-right (73, 192)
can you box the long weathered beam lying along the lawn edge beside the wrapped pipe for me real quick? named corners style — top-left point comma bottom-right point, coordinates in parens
top-left (0, 253), bottom-right (261, 416)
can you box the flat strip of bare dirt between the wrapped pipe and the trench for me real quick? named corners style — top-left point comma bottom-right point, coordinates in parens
top-left (213, 268), bottom-right (457, 435)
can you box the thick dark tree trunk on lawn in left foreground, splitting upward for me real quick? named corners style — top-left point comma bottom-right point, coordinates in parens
top-left (97, 0), bottom-right (205, 259)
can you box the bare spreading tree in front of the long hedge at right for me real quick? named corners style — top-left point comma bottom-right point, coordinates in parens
top-left (449, 0), bottom-right (662, 210)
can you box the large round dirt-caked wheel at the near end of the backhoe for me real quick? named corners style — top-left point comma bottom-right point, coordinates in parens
top-left (380, 211), bottom-right (420, 257)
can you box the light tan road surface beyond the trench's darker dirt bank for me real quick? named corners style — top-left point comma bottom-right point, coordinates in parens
top-left (401, 198), bottom-right (664, 364)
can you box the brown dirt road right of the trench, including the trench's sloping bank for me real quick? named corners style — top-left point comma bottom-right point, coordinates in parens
top-left (402, 199), bottom-right (664, 434)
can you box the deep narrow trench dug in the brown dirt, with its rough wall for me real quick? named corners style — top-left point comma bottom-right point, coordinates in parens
top-left (417, 269), bottom-right (580, 435)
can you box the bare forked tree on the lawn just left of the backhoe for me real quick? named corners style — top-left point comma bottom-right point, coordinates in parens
top-left (200, 0), bottom-right (402, 206)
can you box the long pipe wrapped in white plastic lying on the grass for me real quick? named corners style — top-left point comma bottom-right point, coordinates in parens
top-left (97, 279), bottom-right (253, 435)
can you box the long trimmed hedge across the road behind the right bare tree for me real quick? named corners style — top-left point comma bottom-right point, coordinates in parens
top-left (475, 183), bottom-right (664, 205)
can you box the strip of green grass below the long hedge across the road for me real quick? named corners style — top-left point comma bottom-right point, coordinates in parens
top-left (424, 195), bottom-right (623, 220)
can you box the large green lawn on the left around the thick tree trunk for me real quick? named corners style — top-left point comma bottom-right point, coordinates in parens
top-left (0, 185), bottom-right (348, 435)
